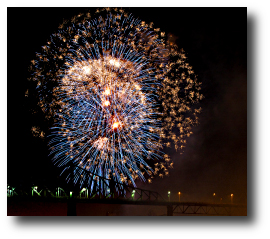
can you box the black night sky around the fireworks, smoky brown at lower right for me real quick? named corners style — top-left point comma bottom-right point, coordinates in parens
top-left (7, 8), bottom-right (247, 202)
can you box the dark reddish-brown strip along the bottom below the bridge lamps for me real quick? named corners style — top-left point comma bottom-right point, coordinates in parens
top-left (7, 197), bottom-right (247, 216)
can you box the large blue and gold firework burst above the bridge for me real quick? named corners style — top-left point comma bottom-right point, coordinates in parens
top-left (27, 8), bottom-right (202, 194)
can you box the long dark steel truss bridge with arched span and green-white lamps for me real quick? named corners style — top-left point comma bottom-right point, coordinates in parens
top-left (7, 165), bottom-right (247, 216)
